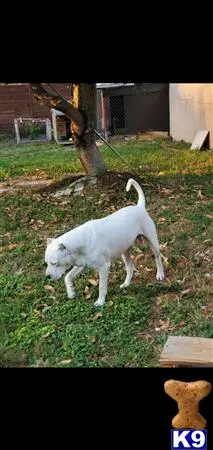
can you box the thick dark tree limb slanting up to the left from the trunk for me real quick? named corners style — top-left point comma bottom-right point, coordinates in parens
top-left (30, 83), bottom-right (86, 136)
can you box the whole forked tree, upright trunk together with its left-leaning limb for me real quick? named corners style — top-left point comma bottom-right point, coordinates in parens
top-left (31, 83), bottom-right (106, 176)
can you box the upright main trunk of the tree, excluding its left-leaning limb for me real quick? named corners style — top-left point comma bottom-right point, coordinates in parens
top-left (71, 83), bottom-right (106, 175)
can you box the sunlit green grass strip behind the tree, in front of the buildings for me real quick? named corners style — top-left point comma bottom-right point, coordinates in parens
top-left (0, 140), bottom-right (212, 182)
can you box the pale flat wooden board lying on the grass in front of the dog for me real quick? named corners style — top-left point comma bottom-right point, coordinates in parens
top-left (160, 336), bottom-right (213, 367)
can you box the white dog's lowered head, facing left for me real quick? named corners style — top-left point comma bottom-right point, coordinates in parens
top-left (45, 238), bottom-right (72, 280)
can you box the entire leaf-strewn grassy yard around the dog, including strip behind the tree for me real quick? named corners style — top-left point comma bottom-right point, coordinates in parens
top-left (0, 140), bottom-right (213, 367)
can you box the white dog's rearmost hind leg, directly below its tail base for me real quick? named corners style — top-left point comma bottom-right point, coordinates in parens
top-left (143, 216), bottom-right (164, 281)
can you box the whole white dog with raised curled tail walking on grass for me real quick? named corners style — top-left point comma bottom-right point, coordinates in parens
top-left (45, 178), bottom-right (164, 306)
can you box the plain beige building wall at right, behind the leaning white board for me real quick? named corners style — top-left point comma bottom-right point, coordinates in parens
top-left (169, 83), bottom-right (213, 148)
